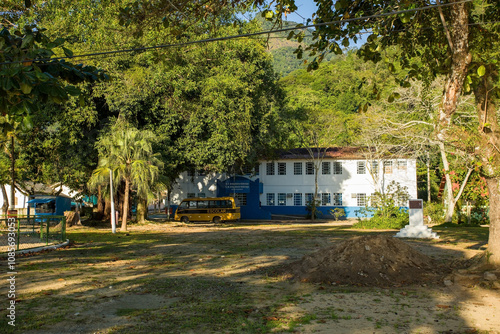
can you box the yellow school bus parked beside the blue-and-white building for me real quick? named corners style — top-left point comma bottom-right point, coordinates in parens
top-left (174, 197), bottom-right (241, 224)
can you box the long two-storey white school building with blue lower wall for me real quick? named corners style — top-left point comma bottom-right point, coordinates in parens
top-left (171, 147), bottom-right (417, 219)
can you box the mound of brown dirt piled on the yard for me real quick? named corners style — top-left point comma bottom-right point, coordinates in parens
top-left (281, 235), bottom-right (443, 286)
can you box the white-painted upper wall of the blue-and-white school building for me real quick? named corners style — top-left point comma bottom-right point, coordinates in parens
top-left (171, 159), bottom-right (417, 206)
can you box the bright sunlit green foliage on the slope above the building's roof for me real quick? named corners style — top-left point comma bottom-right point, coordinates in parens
top-left (281, 52), bottom-right (402, 146)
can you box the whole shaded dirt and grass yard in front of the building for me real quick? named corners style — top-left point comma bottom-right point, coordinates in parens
top-left (0, 222), bottom-right (500, 334)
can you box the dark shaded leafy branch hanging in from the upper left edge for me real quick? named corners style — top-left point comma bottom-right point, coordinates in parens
top-left (0, 26), bottom-right (107, 126)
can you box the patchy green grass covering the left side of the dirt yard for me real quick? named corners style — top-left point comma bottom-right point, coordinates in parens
top-left (5, 224), bottom-right (487, 334)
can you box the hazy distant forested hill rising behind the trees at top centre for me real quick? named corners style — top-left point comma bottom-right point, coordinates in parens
top-left (256, 15), bottom-right (333, 76)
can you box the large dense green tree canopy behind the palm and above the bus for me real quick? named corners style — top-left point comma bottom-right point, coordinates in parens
top-left (3, 0), bottom-right (292, 198)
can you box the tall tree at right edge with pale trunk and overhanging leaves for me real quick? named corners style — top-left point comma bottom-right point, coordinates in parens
top-left (272, 0), bottom-right (500, 265)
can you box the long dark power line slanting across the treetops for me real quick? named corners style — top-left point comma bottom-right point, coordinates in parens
top-left (0, 0), bottom-right (473, 65)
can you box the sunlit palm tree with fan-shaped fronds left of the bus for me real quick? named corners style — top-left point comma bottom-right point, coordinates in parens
top-left (89, 118), bottom-right (163, 231)
